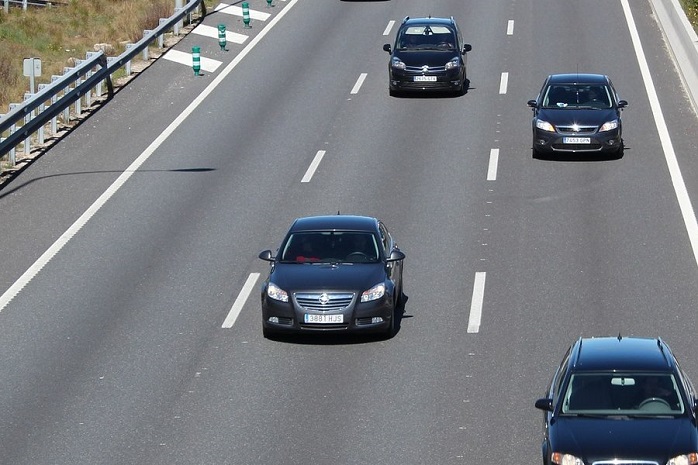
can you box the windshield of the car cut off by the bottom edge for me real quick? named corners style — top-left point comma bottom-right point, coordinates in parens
top-left (562, 373), bottom-right (684, 416)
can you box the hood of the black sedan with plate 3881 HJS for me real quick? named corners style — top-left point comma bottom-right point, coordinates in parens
top-left (270, 263), bottom-right (386, 292)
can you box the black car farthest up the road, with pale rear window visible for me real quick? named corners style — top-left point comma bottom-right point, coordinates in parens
top-left (383, 16), bottom-right (472, 95)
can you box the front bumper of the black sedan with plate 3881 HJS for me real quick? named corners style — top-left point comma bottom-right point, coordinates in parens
top-left (262, 293), bottom-right (395, 333)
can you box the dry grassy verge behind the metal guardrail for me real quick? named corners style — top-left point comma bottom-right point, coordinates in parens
top-left (0, 0), bottom-right (215, 109)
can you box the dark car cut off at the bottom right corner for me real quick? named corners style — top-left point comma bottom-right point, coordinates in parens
top-left (535, 336), bottom-right (698, 465)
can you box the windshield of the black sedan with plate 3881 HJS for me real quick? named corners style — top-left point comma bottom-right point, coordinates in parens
top-left (281, 231), bottom-right (380, 263)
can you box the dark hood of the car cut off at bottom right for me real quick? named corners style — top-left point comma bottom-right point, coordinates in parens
top-left (550, 417), bottom-right (697, 458)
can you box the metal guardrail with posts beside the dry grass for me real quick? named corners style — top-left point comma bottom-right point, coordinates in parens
top-left (0, 0), bottom-right (206, 165)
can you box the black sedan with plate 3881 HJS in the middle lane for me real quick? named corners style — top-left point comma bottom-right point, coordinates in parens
top-left (259, 214), bottom-right (405, 338)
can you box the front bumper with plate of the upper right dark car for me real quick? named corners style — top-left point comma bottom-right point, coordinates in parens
top-left (533, 128), bottom-right (623, 153)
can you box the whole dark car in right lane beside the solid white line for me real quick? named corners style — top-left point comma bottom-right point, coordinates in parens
top-left (528, 73), bottom-right (628, 158)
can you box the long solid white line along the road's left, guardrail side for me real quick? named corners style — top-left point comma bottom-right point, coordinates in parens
top-left (0, 0), bottom-right (298, 311)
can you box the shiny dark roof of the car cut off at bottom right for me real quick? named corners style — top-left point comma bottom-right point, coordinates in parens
top-left (571, 337), bottom-right (675, 372)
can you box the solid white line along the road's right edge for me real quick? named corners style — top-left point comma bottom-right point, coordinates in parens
top-left (621, 0), bottom-right (698, 264)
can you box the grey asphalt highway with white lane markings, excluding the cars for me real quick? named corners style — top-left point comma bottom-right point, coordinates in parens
top-left (0, 0), bottom-right (698, 465)
